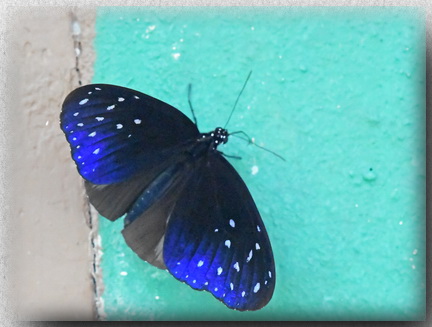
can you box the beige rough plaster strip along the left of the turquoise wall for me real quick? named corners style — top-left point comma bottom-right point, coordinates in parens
top-left (6, 8), bottom-right (95, 320)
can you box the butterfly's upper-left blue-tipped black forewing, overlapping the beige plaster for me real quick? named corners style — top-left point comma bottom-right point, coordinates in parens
top-left (60, 84), bottom-right (199, 185)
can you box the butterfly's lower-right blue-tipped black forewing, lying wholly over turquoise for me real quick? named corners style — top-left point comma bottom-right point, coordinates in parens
top-left (163, 153), bottom-right (276, 310)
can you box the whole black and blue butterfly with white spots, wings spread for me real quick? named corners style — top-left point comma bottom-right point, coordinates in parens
top-left (60, 73), bottom-right (276, 311)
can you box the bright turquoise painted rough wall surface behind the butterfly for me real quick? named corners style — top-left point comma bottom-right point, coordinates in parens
top-left (93, 7), bottom-right (425, 320)
